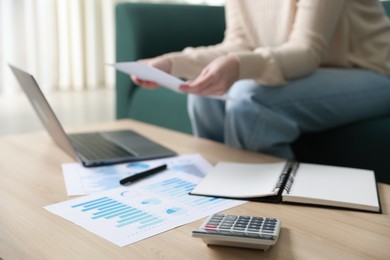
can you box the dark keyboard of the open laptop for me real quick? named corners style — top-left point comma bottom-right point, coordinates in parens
top-left (69, 133), bottom-right (131, 160)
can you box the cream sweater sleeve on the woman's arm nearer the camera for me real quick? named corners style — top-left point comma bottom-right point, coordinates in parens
top-left (236, 0), bottom-right (345, 85)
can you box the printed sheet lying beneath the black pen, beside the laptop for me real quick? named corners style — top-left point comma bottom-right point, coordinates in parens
top-left (62, 154), bottom-right (211, 196)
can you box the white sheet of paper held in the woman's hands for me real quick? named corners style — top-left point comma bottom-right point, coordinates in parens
top-left (107, 61), bottom-right (229, 100)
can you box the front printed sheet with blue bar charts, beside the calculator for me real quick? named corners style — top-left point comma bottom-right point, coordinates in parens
top-left (45, 155), bottom-right (245, 246)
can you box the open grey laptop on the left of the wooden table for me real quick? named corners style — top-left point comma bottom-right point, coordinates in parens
top-left (9, 64), bottom-right (176, 167)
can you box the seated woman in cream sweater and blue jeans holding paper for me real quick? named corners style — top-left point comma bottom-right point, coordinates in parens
top-left (132, 0), bottom-right (390, 159)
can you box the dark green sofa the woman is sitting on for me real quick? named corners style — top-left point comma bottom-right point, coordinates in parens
top-left (116, 2), bottom-right (390, 183)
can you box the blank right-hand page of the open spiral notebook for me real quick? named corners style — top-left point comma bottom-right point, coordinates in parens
top-left (283, 163), bottom-right (379, 207)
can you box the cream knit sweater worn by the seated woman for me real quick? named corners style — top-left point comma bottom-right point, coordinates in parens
top-left (166, 0), bottom-right (390, 85)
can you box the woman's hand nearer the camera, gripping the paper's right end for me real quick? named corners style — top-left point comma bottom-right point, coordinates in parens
top-left (180, 55), bottom-right (239, 96)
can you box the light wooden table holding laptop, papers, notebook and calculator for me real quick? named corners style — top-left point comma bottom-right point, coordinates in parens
top-left (0, 120), bottom-right (390, 260)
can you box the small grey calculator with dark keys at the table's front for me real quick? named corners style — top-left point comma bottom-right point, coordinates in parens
top-left (192, 214), bottom-right (281, 251)
